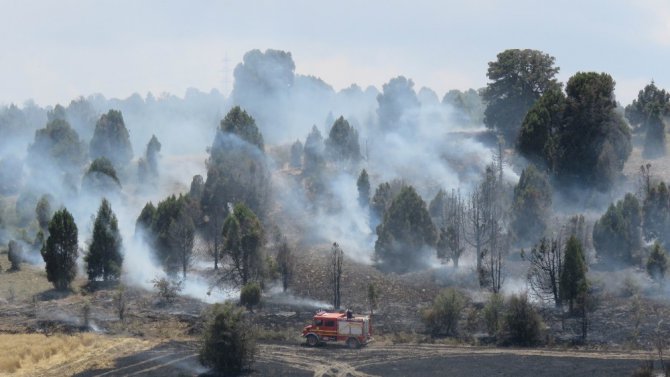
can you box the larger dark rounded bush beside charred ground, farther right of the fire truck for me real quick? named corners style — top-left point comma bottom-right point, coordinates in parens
top-left (505, 294), bottom-right (542, 346)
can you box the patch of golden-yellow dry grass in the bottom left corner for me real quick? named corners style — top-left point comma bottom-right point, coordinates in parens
top-left (0, 333), bottom-right (156, 376)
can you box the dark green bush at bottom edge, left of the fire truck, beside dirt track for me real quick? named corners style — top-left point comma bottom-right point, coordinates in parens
top-left (200, 303), bottom-right (256, 374)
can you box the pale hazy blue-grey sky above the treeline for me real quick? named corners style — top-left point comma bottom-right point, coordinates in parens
top-left (0, 0), bottom-right (670, 105)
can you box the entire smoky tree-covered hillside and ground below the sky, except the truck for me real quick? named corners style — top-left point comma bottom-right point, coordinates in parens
top-left (0, 49), bottom-right (670, 376)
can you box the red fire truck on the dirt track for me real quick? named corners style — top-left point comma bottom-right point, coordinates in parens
top-left (302, 311), bottom-right (372, 348)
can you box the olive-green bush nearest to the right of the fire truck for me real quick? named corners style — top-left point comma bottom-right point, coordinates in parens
top-left (421, 288), bottom-right (465, 336)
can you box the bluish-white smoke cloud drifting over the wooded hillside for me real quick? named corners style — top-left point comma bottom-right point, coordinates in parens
top-left (0, 50), bottom-right (517, 306)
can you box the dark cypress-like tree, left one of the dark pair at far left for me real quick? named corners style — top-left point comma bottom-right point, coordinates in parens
top-left (42, 208), bottom-right (78, 290)
